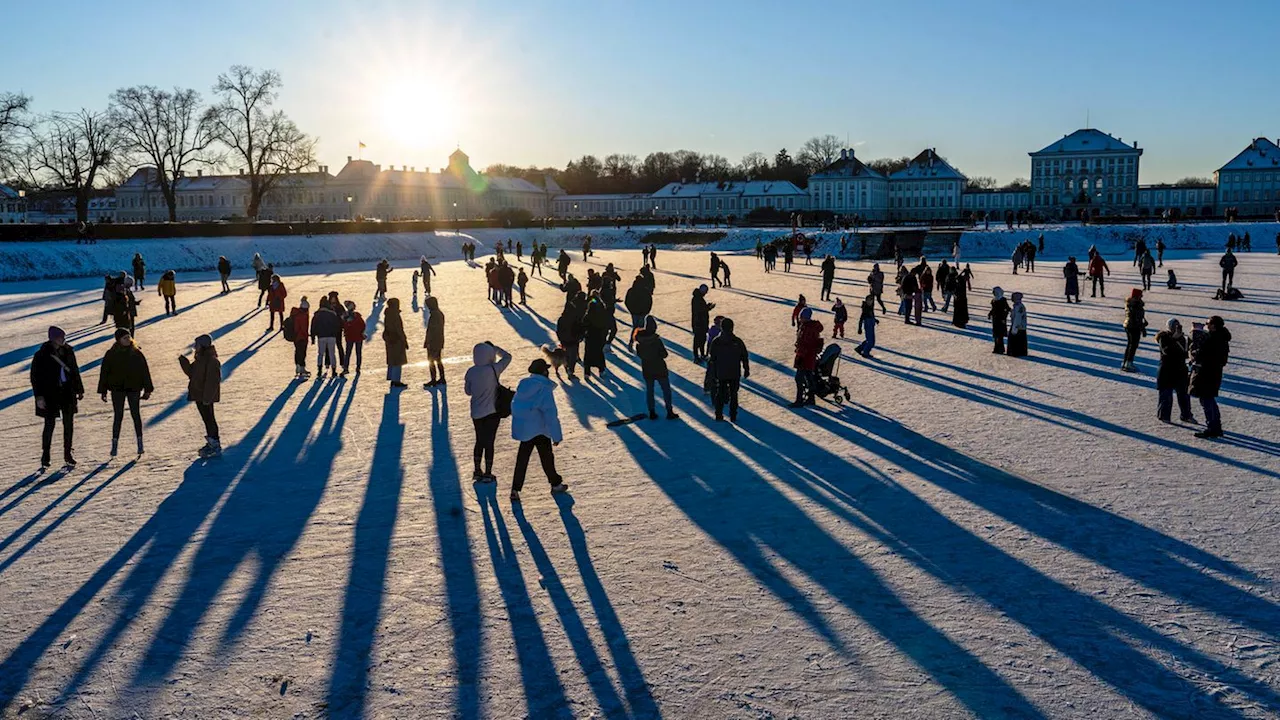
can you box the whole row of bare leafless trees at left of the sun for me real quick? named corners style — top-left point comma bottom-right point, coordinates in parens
top-left (0, 65), bottom-right (316, 222)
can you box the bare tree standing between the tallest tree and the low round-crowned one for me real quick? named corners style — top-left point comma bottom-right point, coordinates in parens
top-left (111, 85), bottom-right (214, 223)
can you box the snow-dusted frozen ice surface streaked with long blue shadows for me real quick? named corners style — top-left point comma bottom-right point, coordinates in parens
top-left (0, 234), bottom-right (1280, 719)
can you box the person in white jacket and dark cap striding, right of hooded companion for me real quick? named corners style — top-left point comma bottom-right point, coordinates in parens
top-left (511, 359), bottom-right (568, 502)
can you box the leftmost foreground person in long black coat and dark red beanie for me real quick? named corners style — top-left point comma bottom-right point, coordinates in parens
top-left (31, 327), bottom-right (84, 468)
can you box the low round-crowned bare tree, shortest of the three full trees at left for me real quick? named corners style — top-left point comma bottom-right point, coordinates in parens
top-left (22, 109), bottom-right (120, 223)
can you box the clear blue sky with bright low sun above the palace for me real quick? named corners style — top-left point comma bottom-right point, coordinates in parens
top-left (10, 0), bottom-right (1280, 183)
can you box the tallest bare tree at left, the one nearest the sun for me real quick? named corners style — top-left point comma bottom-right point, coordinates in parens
top-left (205, 65), bottom-right (316, 219)
